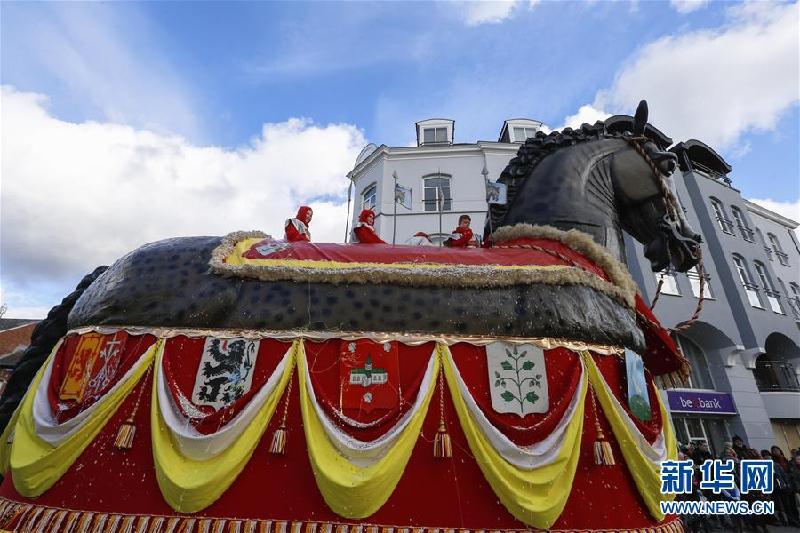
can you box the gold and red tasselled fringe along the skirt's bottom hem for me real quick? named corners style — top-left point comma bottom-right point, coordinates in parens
top-left (0, 497), bottom-right (684, 533)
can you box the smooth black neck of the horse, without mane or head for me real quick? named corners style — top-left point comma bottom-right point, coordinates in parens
top-left (503, 141), bottom-right (625, 263)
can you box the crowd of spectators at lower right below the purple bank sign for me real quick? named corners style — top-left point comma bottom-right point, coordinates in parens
top-left (678, 435), bottom-right (800, 533)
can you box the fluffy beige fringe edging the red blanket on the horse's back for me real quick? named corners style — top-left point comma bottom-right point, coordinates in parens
top-left (209, 228), bottom-right (637, 309)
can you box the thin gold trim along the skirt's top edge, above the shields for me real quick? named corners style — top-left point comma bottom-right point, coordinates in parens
top-left (67, 326), bottom-right (625, 355)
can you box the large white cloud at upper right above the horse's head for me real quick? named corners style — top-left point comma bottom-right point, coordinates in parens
top-left (592, 2), bottom-right (800, 149)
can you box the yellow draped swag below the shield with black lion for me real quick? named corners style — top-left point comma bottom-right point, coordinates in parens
top-left (150, 340), bottom-right (301, 513)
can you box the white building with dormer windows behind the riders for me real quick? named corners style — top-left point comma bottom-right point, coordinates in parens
top-left (347, 118), bottom-right (542, 244)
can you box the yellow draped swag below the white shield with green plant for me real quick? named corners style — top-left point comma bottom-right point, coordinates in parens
top-left (439, 345), bottom-right (586, 529)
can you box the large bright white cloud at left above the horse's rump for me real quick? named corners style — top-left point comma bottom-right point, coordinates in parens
top-left (1, 86), bottom-right (365, 316)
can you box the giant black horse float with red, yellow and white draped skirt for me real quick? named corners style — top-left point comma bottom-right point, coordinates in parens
top-left (0, 103), bottom-right (700, 533)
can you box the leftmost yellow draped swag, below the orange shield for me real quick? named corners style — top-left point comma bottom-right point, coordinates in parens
top-left (0, 343), bottom-right (158, 498)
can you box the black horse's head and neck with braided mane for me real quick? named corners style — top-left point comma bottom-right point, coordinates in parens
top-left (486, 101), bottom-right (700, 272)
